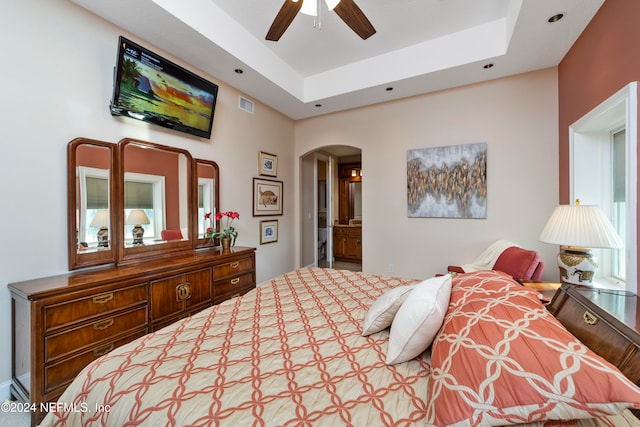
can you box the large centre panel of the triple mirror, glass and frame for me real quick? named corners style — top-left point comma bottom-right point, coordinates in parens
top-left (117, 139), bottom-right (193, 262)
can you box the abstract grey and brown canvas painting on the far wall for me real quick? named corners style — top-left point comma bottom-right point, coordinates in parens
top-left (407, 142), bottom-right (487, 218)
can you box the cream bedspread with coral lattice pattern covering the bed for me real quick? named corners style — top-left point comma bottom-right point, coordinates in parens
top-left (41, 268), bottom-right (638, 427)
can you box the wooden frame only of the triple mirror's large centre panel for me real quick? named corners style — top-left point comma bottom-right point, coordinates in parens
top-left (115, 138), bottom-right (194, 264)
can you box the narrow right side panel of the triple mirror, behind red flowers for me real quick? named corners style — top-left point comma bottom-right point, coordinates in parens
top-left (194, 159), bottom-right (220, 248)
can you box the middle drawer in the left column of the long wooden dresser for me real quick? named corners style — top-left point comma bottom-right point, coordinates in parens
top-left (44, 306), bottom-right (147, 363)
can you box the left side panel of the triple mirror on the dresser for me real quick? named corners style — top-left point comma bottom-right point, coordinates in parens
top-left (67, 138), bottom-right (117, 270)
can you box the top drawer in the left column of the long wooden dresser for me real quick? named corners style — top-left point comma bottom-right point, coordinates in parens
top-left (44, 283), bottom-right (147, 331)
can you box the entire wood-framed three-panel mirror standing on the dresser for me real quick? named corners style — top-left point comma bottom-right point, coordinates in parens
top-left (68, 138), bottom-right (219, 270)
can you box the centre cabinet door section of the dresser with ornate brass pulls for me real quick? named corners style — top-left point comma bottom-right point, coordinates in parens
top-left (151, 268), bottom-right (213, 321)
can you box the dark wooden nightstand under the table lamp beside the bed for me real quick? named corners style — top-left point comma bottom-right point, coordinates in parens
top-left (547, 284), bottom-right (640, 418)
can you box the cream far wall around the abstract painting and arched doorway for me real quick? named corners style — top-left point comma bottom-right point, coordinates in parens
top-left (295, 68), bottom-right (558, 281)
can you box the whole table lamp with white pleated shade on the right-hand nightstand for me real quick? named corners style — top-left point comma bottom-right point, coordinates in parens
top-left (539, 200), bottom-right (624, 286)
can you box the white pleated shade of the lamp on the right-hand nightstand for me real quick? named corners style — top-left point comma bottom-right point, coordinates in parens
top-left (539, 205), bottom-right (624, 248)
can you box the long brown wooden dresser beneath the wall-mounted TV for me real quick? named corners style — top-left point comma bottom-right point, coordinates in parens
top-left (9, 247), bottom-right (256, 424)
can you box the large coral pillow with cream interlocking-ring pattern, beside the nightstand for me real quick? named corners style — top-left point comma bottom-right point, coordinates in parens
top-left (427, 271), bottom-right (640, 426)
